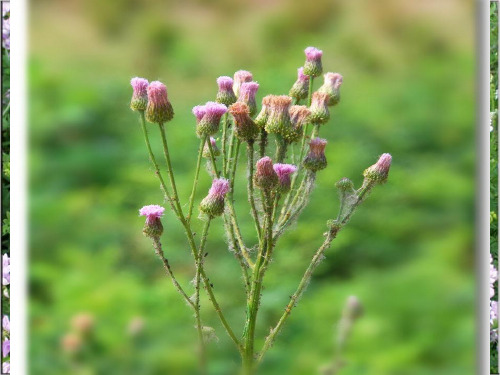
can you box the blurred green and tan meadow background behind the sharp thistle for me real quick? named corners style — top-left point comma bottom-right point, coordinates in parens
top-left (29, 0), bottom-right (475, 375)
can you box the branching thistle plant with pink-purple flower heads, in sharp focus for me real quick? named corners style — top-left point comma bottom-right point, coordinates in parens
top-left (130, 47), bottom-right (391, 375)
